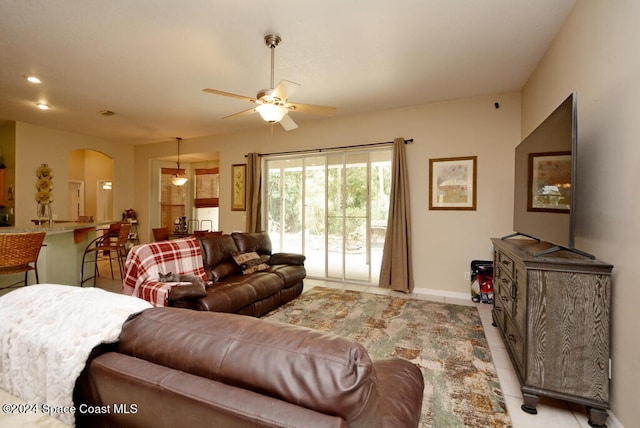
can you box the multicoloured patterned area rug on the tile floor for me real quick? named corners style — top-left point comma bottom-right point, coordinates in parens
top-left (264, 287), bottom-right (511, 428)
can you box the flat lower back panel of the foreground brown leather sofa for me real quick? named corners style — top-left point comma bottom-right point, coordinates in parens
top-left (81, 352), bottom-right (347, 428)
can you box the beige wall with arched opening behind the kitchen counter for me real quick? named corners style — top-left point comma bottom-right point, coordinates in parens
top-left (14, 122), bottom-right (134, 227)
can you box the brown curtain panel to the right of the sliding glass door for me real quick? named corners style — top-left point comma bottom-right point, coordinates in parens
top-left (379, 138), bottom-right (413, 293)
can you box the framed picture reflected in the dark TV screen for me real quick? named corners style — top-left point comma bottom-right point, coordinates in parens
top-left (527, 152), bottom-right (571, 213)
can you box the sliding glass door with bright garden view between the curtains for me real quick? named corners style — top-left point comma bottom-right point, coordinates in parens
top-left (264, 148), bottom-right (391, 284)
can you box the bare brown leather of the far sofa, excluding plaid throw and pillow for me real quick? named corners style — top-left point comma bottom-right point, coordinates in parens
top-left (169, 232), bottom-right (307, 317)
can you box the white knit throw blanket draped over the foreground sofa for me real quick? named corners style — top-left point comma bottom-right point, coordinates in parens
top-left (0, 284), bottom-right (151, 425)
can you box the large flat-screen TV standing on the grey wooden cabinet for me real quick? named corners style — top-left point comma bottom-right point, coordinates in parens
top-left (505, 93), bottom-right (591, 257)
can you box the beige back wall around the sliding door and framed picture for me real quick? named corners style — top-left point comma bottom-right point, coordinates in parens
top-left (134, 93), bottom-right (520, 296)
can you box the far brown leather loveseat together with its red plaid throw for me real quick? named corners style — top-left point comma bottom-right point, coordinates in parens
top-left (123, 232), bottom-right (306, 317)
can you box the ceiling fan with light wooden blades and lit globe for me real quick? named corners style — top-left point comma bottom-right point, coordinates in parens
top-left (203, 34), bottom-right (336, 131)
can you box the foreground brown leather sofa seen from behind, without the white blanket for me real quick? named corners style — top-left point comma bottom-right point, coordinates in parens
top-left (74, 307), bottom-right (424, 428)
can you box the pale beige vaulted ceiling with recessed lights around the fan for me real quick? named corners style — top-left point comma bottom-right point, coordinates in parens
top-left (0, 0), bottom-right (575, 144)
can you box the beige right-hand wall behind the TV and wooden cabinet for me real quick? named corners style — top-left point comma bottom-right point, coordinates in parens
top-left (522, 0), bottom-right (640, 427)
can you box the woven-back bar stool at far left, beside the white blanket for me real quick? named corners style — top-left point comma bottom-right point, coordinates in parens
top-left (0, 232), bottom-right (46, 288)
